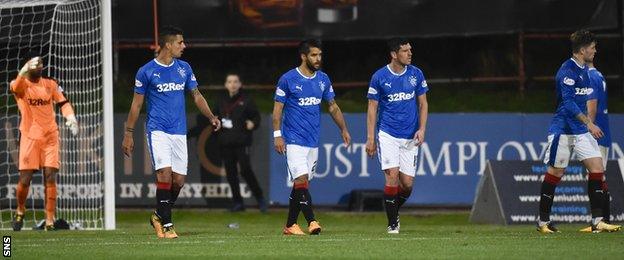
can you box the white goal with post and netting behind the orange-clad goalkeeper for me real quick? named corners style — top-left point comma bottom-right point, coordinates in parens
top-left (0, 0), bottom-right (115, 229)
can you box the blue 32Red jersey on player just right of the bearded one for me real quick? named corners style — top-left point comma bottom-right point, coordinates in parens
top-left (367, 65), bottom-right (429, 139)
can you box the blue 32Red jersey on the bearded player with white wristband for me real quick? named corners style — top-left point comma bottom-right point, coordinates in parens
top-left (275, 68), bottom-right (335, 147)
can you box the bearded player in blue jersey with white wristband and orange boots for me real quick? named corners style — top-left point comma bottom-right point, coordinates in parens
top-left (273, 40), bottom-right (351, 235)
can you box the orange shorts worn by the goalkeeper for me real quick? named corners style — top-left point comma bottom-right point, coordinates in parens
top-left (18, 130), bottom-right (60, 171)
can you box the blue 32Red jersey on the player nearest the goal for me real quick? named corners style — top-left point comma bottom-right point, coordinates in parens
top-left (134, 59), bottom-right (197, 135)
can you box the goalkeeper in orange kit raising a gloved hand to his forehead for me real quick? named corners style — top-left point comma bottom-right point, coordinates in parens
top-left (10, 51), bottom-right (78, 231)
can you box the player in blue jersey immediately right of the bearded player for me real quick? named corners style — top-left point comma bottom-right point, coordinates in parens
top-left (366, 38), bottom-right (429, 234)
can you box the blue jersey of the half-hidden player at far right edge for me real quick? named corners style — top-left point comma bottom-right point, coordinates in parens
top-left (588, 68), bottom-right (611, 147)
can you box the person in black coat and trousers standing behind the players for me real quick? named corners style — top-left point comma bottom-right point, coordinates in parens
top-left (214, 73), bottom-right (267, 212)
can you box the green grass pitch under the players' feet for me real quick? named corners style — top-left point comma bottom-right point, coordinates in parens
top-left (2, 210), bottom-right (624, 259)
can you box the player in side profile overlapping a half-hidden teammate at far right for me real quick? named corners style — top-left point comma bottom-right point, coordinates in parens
top-left (537, 30), bottom-right (621, 234)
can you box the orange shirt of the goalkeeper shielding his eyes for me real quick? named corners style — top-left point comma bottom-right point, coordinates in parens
top-left (11, 76), bottom-right (67, 139)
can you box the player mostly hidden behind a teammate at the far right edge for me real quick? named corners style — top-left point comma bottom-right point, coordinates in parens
top-left (585, 62), bottom-right (611, 225)
